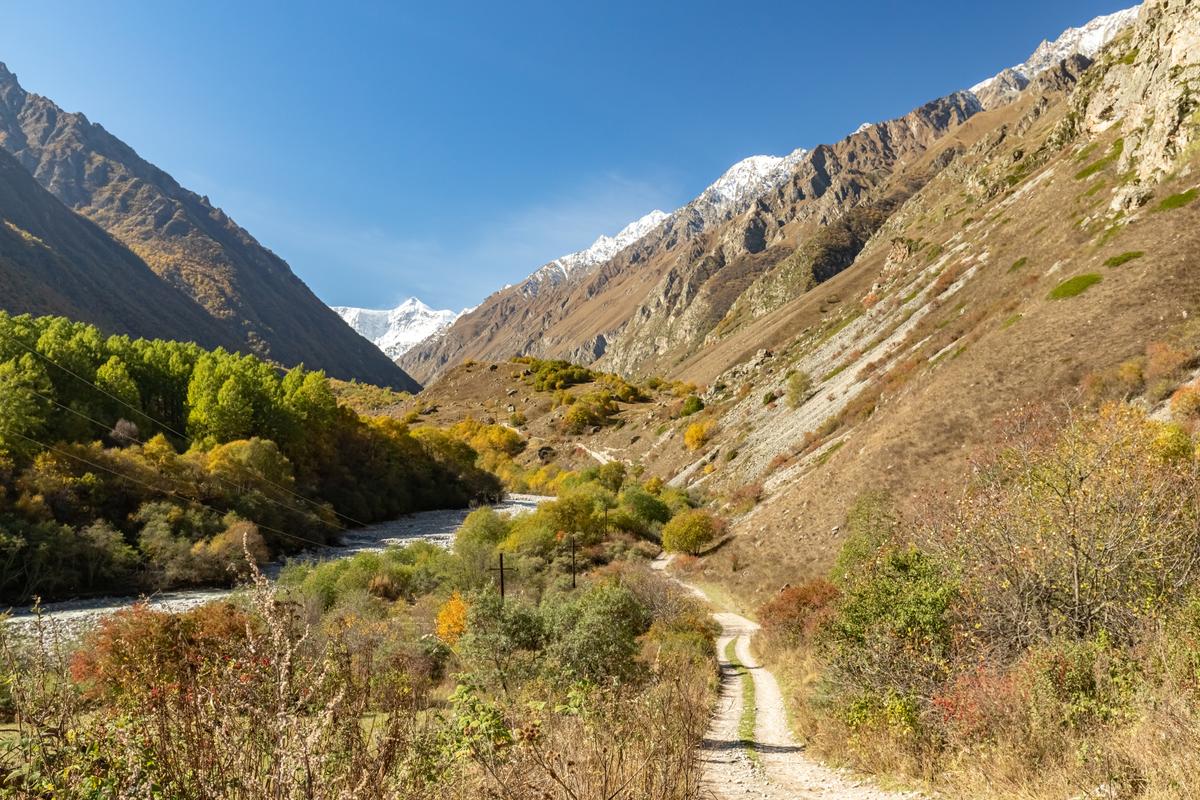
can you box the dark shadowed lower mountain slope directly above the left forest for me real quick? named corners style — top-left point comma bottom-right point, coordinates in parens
top-left (0, 150), bottom-right (236, 348)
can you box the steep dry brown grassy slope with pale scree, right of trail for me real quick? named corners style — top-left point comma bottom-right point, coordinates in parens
top-left (678, 4), bottom-right (1200, 601)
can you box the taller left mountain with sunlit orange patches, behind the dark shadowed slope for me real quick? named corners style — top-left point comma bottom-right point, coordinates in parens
top-left (0, 64), bottom-right (419, 391)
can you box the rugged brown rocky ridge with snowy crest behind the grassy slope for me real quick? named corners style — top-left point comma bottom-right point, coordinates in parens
top-left (400, 10), bottom-right (1136, 383)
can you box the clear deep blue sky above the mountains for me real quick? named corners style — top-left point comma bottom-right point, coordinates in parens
top-left (0, 0), bottom-right (1129, 307)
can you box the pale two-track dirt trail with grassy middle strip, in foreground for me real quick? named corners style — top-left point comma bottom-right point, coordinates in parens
top-left (653, 557), bottom-right (922, 800)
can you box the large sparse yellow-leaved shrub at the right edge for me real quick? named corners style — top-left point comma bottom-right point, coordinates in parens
top-left (930, 405), bottom-right (1200, 651)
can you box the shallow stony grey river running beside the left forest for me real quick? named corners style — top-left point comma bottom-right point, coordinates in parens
top-left (8, 494), bottom-right (553, 630)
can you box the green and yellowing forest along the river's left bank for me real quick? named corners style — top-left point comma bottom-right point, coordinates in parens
top-left (0, 313), bottom-right (502, 602)
